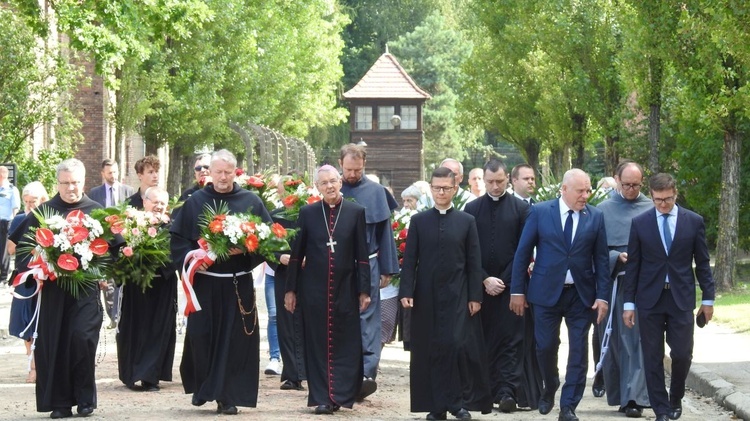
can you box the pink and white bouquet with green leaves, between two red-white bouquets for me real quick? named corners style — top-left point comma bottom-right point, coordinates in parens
top-left (94, 206), bottom-right (171, 291)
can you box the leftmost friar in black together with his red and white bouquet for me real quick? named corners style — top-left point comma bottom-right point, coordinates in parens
top-left (11, 159), bottom-right (122, 418)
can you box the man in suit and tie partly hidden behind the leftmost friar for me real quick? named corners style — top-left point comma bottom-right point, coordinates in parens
top-left (89, 159), bottom-right (135, 329)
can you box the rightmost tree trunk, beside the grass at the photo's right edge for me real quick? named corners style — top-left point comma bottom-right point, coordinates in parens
top-left (714, 130), bottom-right (742, 291)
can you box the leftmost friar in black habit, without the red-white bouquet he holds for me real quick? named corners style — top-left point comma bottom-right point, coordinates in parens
top-left (10, 158), bottom-right (122, 418)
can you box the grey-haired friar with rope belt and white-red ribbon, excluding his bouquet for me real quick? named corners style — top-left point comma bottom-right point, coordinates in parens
top-left (170, 150), bottom-right (272, 415)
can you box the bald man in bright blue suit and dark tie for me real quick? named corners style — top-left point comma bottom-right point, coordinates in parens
top-left (510, 168), bottom-right (611, 421)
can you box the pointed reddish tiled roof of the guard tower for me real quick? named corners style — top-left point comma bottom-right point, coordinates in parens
top-left (344, 50), bottom-right (432, 99)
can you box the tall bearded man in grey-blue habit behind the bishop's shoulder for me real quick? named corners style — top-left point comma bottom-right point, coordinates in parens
top-left (339, 143), bottom-right (399, 400)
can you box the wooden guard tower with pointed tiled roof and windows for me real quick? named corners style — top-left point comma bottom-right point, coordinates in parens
top-left (344, 47), bottom-right (431, 202)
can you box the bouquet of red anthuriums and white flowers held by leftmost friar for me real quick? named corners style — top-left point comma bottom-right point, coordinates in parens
top-left (13, 207), bottom-right (111, 298)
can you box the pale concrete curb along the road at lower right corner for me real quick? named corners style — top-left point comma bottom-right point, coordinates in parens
top-left (664, 356), bottom-right (750, 421)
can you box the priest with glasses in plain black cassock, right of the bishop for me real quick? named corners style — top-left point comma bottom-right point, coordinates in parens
top-left (399, 167), bottom-right (492, 420)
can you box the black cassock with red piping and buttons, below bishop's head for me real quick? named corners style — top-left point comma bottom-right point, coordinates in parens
top-left (286, 200), bottom-right (370, 408)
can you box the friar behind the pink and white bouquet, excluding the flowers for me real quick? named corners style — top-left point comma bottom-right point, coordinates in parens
top-left (116, 187), bottom-right (177, 392)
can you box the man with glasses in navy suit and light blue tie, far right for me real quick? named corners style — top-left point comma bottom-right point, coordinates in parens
top-left (622, 173), bottom-right (715, 421)
